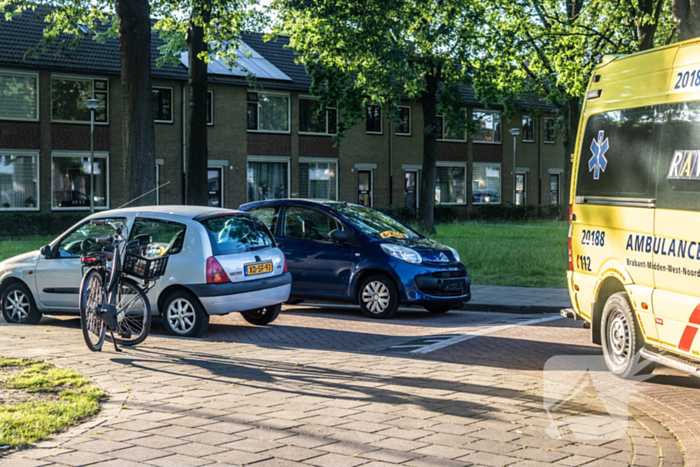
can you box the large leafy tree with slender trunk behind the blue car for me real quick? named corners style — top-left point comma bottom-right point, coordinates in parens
top-left (272, 0), bottom-right (488, 234)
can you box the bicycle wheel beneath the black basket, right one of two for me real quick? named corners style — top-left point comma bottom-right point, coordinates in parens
top-left (114, 277), bottom-right (151, 345)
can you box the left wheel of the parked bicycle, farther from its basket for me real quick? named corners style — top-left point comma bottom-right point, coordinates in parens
top-left (80, 269), bottom-right (107, 352)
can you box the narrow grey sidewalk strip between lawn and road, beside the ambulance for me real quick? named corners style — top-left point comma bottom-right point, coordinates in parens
top-left (462, 285), bottom-right (571, 313)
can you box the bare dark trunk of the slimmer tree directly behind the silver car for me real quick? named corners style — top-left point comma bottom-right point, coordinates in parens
top-left (185, 2), bottom-right (211, 207)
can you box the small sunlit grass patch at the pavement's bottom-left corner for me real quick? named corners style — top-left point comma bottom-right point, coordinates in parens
top-left (0, 357), bottom-right (104, 447)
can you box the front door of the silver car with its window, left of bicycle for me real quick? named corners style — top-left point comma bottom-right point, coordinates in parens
top-left (36, 218), bottom-right (126, 311)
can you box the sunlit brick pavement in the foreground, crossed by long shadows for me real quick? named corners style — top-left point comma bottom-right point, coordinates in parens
top-left (0, 325), bottom-right (682, 467)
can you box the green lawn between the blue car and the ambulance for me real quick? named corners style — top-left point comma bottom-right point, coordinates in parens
top-left (432, 221), bottom-right (569, 287)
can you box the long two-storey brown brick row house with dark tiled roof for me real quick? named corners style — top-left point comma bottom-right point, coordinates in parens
top-left (0, 12), bottom-right (564, 216)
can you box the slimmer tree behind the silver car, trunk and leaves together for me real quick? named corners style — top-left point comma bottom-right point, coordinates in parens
top-left (154, 0), bottom-right (265, 206)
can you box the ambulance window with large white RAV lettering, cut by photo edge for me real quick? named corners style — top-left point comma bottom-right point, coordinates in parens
top-left (656, 102), bottom-right (700, 211)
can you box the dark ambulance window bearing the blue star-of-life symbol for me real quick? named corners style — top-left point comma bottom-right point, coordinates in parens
top-left (576, 107), bottom-right (658, 198)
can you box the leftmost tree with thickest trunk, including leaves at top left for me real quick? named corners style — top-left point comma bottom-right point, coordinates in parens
top-left (0, 0), bottom-right (156, 205)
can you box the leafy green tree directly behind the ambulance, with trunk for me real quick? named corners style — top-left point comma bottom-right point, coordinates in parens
top-left (473, 0), bottom-right (674, 213)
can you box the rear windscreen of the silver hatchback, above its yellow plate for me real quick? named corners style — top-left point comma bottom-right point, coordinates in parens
top-left (202, 214), bottom-right (275, 256)
